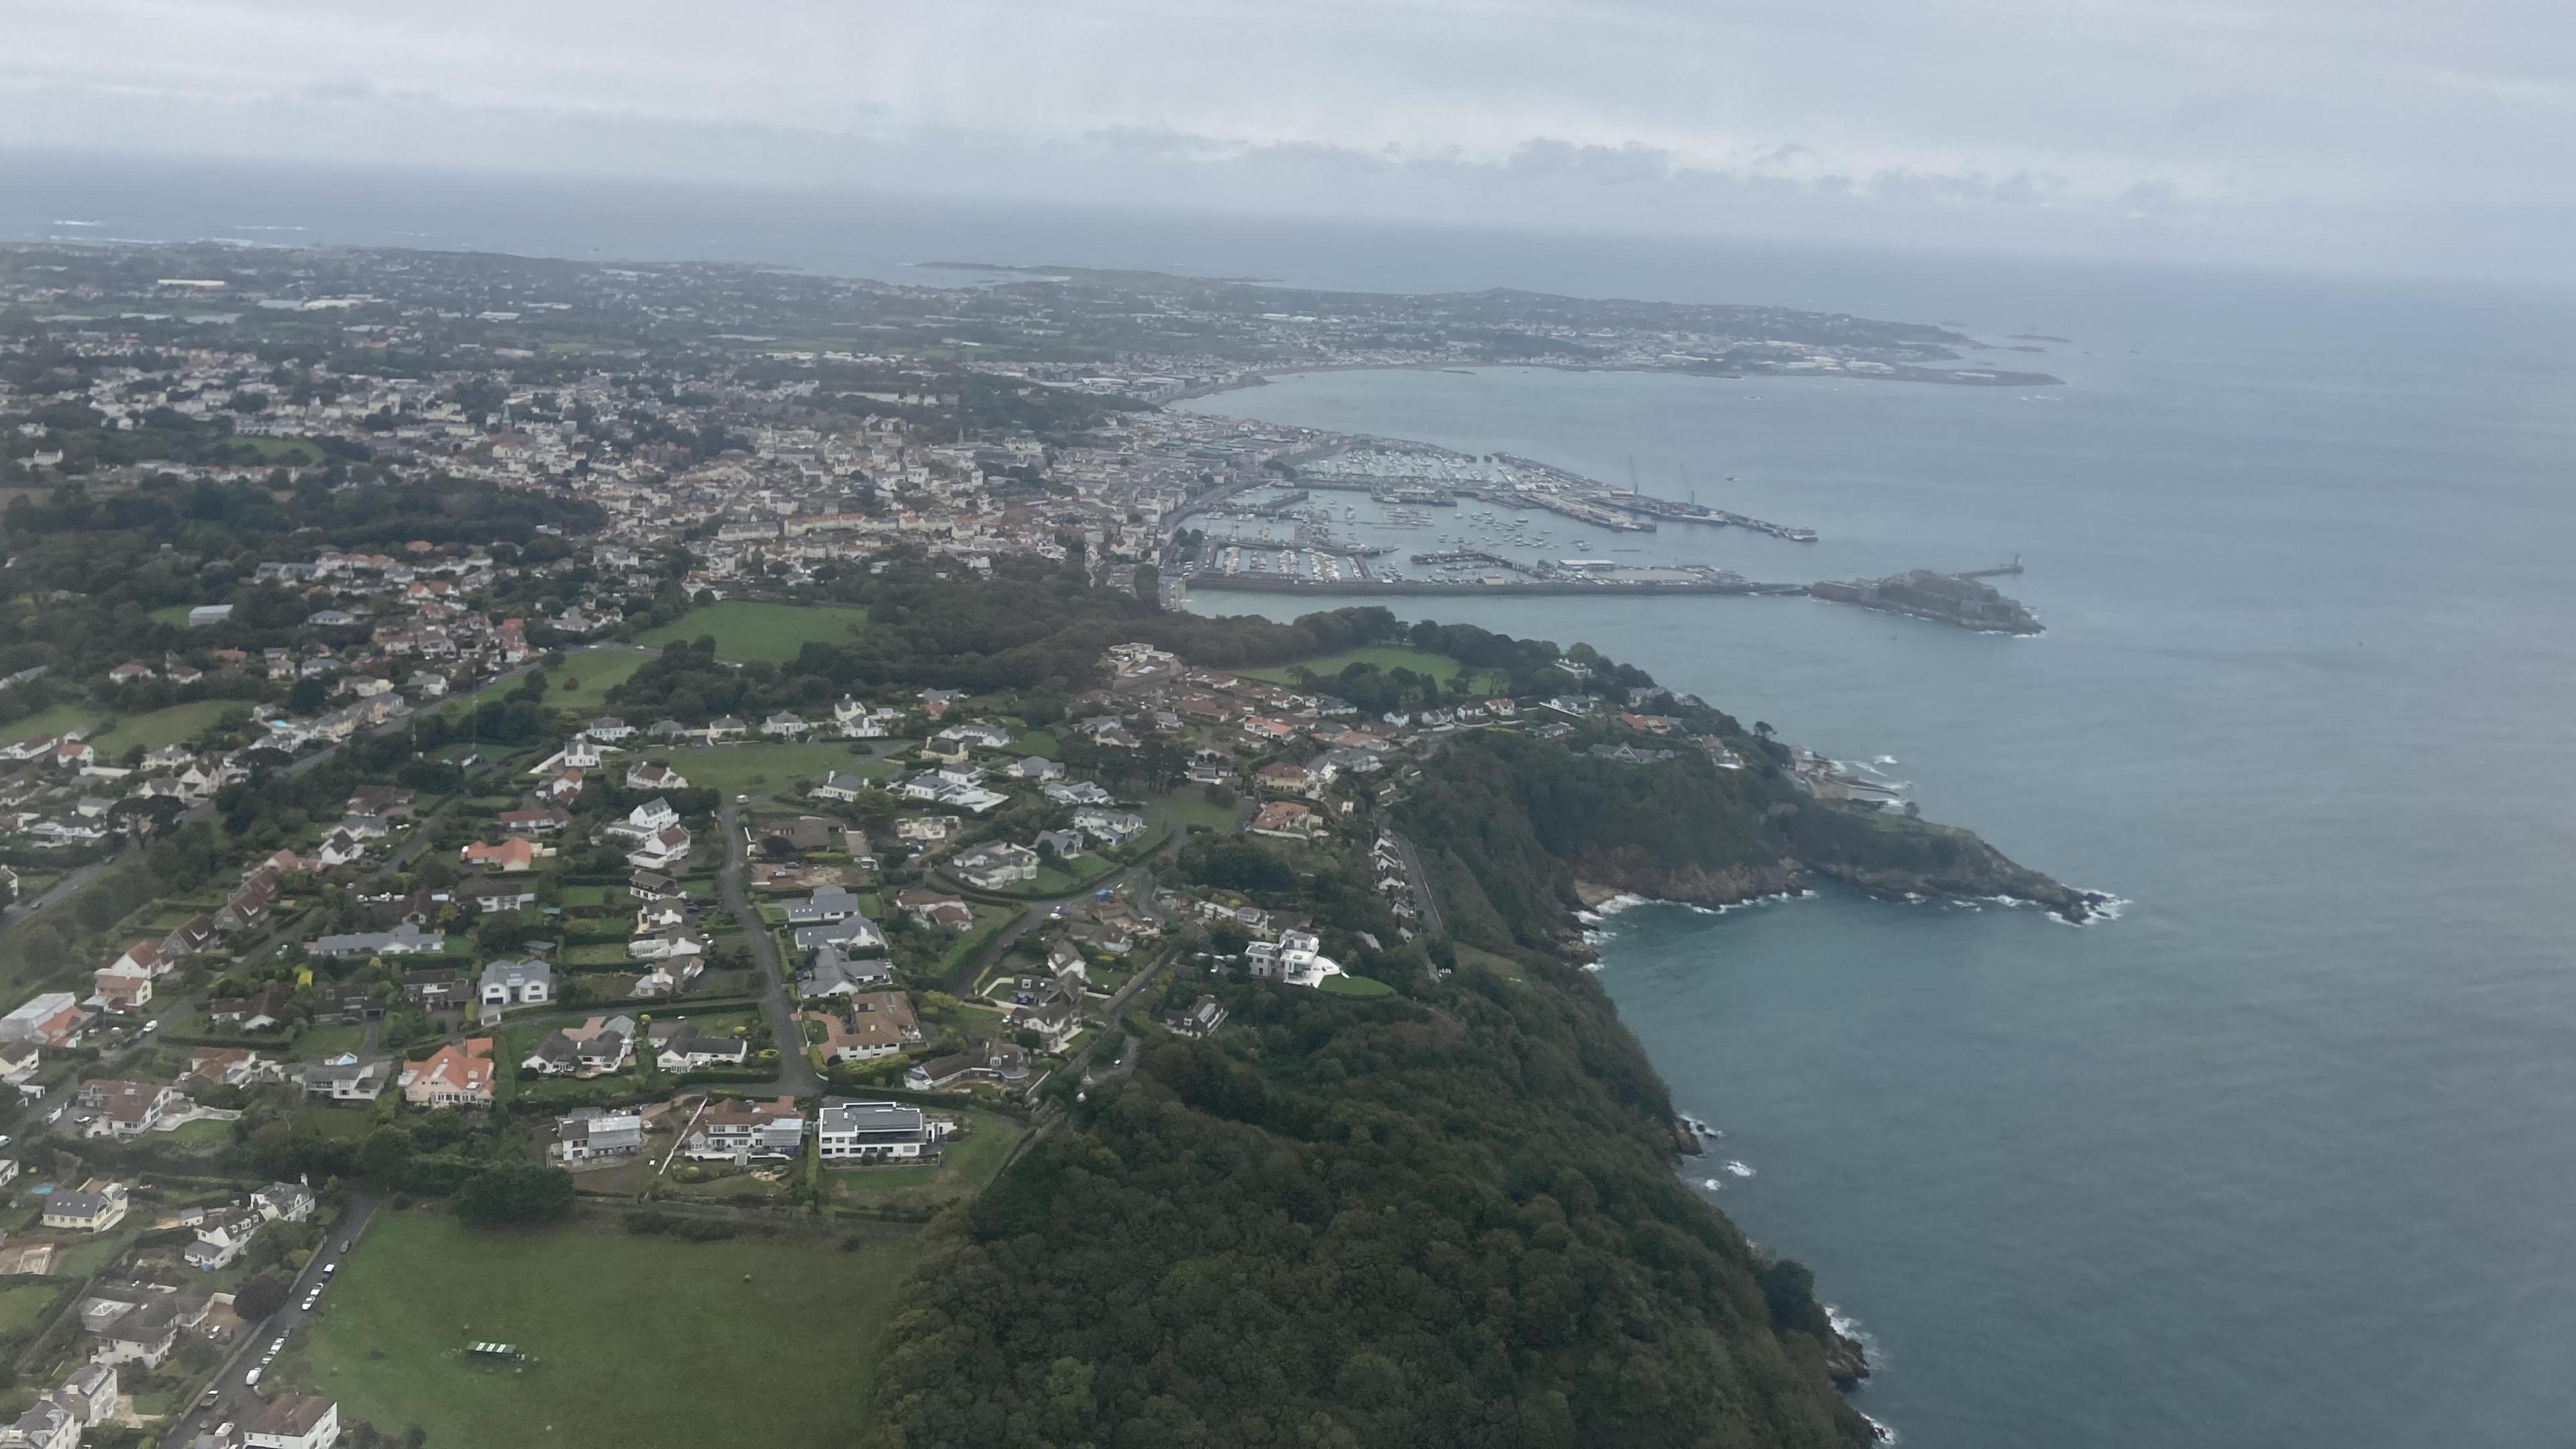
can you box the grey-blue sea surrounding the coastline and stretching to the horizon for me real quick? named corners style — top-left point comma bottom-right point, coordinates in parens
top-left (15, 155), bottom-right (2576, 1449)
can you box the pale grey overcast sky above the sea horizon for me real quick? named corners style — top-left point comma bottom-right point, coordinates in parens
top-left (0, 0), bottom-right (2576, 281)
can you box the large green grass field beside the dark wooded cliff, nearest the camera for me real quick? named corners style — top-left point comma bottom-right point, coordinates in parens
top-left (307, 1212), bottom-right (912, 1449)
